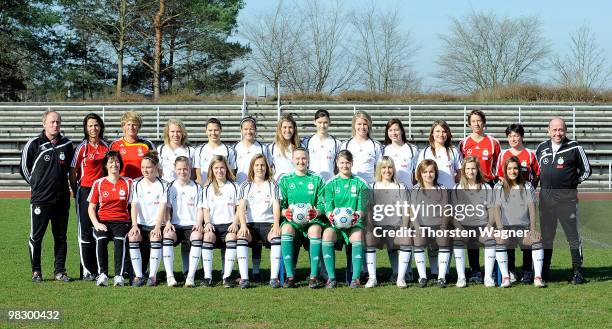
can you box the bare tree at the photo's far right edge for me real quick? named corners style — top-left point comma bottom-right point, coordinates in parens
top-left (551, 25), bottom-right (612, 89)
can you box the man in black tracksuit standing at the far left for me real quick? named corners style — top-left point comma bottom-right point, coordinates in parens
top-left (20, 111), bottom-right (74, 282)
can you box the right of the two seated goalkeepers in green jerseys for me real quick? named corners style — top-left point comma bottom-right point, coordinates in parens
top-left (322, 150), bottom-right (369, 288)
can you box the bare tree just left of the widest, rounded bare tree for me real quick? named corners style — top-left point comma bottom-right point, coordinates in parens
top-left (353, 4), bottom-right (420, 93)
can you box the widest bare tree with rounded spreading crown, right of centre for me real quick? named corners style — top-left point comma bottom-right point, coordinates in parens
top-left (438, 13), bottom-right (550, 92)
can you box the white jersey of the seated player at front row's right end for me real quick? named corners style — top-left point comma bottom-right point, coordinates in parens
top-left (494, 182), bottom-right (536, 227)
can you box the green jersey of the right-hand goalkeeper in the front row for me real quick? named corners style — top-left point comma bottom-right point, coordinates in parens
top-left (324, 175), bottom-right (369, 216)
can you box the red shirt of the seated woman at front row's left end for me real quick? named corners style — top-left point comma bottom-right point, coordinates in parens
top-left (87, 177), bottom-right (132, 222)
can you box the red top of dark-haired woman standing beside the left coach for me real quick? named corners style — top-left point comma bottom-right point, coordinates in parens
top-left (70, 140), bottom-right (109, 187)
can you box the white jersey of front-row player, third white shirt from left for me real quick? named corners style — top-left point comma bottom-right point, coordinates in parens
top-left (200, 181), bottom-right (238, 225)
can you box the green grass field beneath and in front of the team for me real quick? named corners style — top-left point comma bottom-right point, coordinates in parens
top-left (0, 199), bottom-right (612, 329)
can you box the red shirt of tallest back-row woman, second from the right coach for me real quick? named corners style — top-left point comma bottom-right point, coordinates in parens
top-left (459, 135), bottom-right (501, 181)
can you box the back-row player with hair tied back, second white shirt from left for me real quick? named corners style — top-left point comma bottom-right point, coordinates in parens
top-left (194, 118), bottom-right (236, 184)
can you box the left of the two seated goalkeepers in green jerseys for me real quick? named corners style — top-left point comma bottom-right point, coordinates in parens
top-left (278, 147), bottom-right (329, 289)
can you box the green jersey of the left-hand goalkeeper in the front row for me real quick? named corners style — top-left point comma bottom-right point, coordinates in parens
top-left (278, 171), bottom-right (325, 214)
